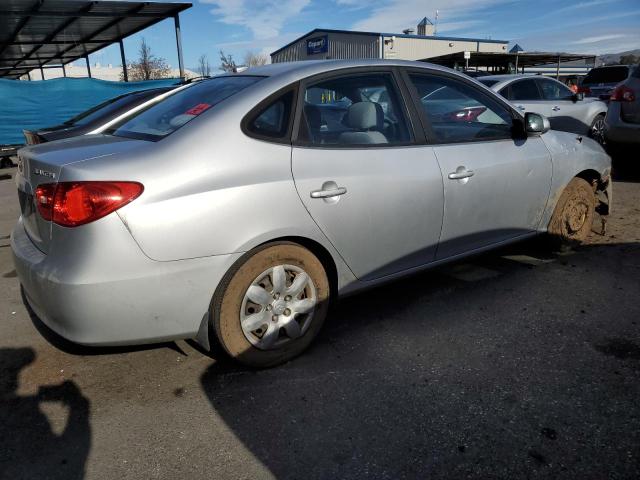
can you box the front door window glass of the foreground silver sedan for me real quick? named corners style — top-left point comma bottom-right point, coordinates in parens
top-left (409, 74), bottom-right (512, 143)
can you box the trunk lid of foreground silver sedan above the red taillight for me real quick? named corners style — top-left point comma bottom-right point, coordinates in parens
top-left (15, 135), bottom-right (147, 253)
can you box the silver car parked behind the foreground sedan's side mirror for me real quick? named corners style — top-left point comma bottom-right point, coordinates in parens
top-left (478, 75), bottom-right (607, 143)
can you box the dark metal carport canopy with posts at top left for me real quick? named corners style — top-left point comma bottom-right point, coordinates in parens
top-left (0, 0), bottom-right (192, 78)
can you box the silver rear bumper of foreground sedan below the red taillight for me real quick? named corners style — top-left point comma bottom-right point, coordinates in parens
top-left (11, 217), bottom-right (240, 345)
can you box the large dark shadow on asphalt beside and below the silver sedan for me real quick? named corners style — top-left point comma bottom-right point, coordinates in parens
top-left (201, 242), bottom-right (640, 479)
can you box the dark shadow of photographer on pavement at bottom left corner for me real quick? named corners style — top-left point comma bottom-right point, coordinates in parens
top-left (0, 348), bottom-right (91, 480)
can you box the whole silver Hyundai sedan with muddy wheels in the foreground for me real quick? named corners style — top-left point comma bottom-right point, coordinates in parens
top-left (11, 60), bottom-right (611, 367)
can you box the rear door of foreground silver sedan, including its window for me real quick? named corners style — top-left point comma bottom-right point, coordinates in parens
top-left (292, 69), bottom-right (443, 280)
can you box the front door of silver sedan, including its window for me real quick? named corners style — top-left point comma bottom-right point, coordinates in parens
top-left (408, 70), bottom-right (551, 259)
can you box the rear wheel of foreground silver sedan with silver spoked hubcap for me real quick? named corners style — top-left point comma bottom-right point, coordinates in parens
top-left (210, 242), bottom-right (330, 368)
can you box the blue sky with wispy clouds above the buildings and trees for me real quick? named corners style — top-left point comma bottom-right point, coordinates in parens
top-left (82, 0), bottom-right (640, 70)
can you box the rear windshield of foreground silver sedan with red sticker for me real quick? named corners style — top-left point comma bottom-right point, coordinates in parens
top-left (107, 75), bottom-right (264, 141)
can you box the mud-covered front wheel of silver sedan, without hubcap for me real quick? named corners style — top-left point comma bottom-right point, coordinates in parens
top-left (548, 177), bottom-right (596, 244)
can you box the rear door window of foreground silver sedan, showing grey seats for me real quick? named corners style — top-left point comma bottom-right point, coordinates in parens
top-left (298, 73), bottom-right (411, 145)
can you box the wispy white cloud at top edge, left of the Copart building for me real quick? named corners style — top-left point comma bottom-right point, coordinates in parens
top-left (200, 0), bottom-right (311, 39)
